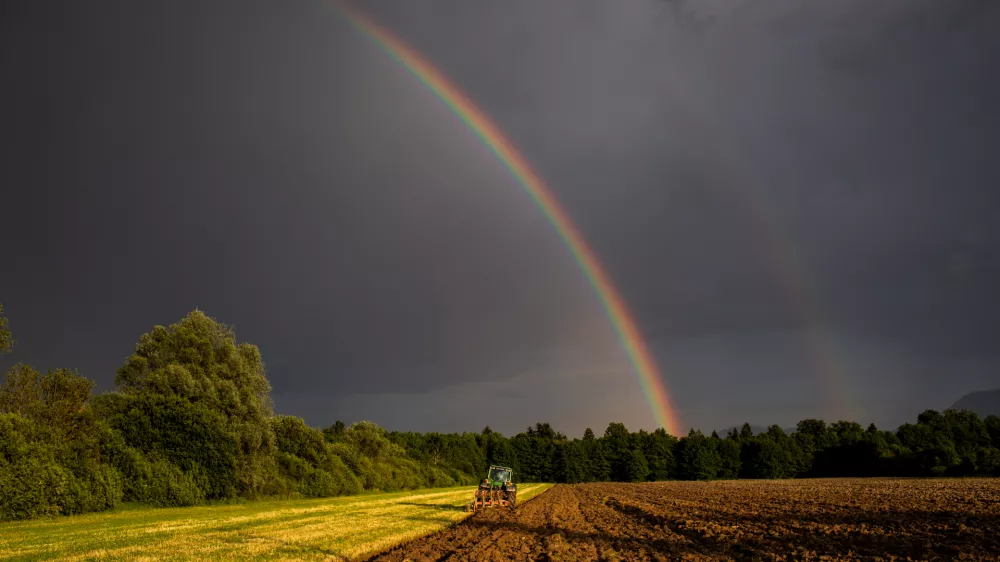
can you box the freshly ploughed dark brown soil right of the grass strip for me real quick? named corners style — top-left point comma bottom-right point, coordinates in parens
top-left (364, 479), bottom-right (1000, 562)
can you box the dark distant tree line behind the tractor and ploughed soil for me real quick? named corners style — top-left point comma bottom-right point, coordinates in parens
top-left (389, 410), bottom-right (1000, 483)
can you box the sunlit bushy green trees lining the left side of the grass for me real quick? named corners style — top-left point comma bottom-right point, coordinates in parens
top-left (0, 309), bottom-right (481, 520)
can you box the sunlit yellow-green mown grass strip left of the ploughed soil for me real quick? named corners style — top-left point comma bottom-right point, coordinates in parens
top-left (0, 484), bottom-right (550, 561)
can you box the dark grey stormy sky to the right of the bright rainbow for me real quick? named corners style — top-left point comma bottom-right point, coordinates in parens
top-left (338, 1), bottom-right (1000, 427)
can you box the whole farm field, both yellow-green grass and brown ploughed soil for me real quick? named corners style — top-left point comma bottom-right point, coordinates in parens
top-left (0, 479), bottom-right (1000, 562)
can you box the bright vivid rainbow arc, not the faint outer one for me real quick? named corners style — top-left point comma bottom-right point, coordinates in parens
top-left (334, 0), bottom-right (681, 435)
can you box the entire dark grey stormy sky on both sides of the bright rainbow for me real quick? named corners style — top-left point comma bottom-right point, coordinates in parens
top-left (0, 0), bottom-right (1000, 435)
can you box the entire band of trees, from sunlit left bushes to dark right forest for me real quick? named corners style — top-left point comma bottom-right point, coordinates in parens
top-left (0, 308), bottom-right (1000, 520)
